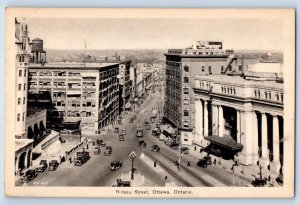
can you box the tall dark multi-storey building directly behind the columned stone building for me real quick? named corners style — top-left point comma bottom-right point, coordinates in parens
top-left (164, 41), bottom-right (236, 145)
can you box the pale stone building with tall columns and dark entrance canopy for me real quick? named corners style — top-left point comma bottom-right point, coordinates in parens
top-left (193, 54), bottom-right (284, 174)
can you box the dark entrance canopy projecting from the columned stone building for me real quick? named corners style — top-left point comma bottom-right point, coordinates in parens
top-left (204, 135), bottom-right (244, 151)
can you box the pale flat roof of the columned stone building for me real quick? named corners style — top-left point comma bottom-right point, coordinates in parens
top-left (195, 75), bottom-right (283, 89)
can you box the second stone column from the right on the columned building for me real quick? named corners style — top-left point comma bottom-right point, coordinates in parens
top-left (261, 113), bottom-right (269, 167)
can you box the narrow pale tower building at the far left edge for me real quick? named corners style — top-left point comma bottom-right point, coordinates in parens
top-left (14, 19), bottom-right (33, 175)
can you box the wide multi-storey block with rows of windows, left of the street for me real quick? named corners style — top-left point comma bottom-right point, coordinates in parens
top-left (29, 63), bottom-right (119, 134)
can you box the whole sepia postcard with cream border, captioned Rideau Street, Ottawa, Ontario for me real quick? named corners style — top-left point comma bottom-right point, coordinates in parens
top-left (5, 8), bottom-right (295, 198)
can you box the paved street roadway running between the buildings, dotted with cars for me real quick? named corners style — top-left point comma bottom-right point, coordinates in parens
top-left (17, 89), bottom-right (249, 186)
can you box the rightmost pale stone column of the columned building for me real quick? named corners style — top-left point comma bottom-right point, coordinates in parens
top-left (273, 116), bottom-right (280, 174)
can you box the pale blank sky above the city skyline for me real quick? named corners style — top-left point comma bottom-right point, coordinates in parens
top-left (26, 18), bottom-right (283, 51)
